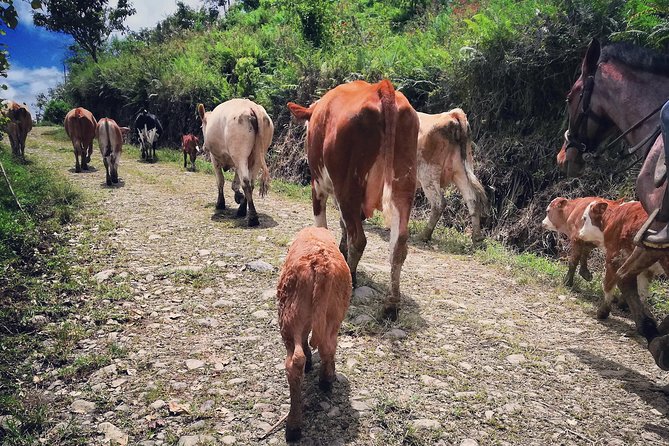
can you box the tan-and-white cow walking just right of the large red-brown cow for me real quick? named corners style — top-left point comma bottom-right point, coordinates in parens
top-left (417, 108), bottom-right (487, 242)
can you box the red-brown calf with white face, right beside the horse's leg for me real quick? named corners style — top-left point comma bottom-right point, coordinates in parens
top-left (579, 199), bottom-right (669, 319)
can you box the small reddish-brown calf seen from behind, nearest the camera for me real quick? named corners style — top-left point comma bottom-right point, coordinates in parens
top-left (277, 227), bottom-right (351, 441)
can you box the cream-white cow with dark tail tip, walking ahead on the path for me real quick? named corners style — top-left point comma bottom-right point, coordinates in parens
top-left (197, 99), bottom-right (274, 226)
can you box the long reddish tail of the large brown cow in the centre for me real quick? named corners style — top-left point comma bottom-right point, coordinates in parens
top-left (379, 79), bottom-right (398, 226)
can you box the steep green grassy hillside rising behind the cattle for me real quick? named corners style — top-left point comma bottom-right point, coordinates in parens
top-left (49, 0), bottom-right (669, 251)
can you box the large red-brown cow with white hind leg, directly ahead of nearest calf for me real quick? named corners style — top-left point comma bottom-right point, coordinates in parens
top-left (288, 80), bottom-right (419, 319)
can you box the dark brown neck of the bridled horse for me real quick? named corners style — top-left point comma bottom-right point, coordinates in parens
top-left (598, 64), bottom-right (669, 145)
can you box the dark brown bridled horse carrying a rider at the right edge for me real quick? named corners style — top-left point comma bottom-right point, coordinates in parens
top-left (557, 40), bottom-right (669, 370)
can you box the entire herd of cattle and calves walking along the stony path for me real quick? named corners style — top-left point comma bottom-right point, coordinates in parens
top-left (5, 80), bottom-right (669, 441)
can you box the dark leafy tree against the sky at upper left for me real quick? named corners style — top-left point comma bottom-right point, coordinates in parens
top-left (33, 0), bottom-right (135, 63)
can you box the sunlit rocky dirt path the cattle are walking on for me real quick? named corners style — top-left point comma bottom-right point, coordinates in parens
top-left (23, 128), bottom-right (669, 446)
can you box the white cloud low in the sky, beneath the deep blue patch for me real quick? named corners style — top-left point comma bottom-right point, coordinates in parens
top-left (0, 65), bottom-right (63, 113)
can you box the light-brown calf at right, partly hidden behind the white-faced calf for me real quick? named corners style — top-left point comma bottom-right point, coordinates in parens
top-left (541, 197), bottom-right (604, 287)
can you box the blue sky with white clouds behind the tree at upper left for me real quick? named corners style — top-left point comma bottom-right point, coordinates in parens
top-left (0, 0), bottom-right (202, 113)
